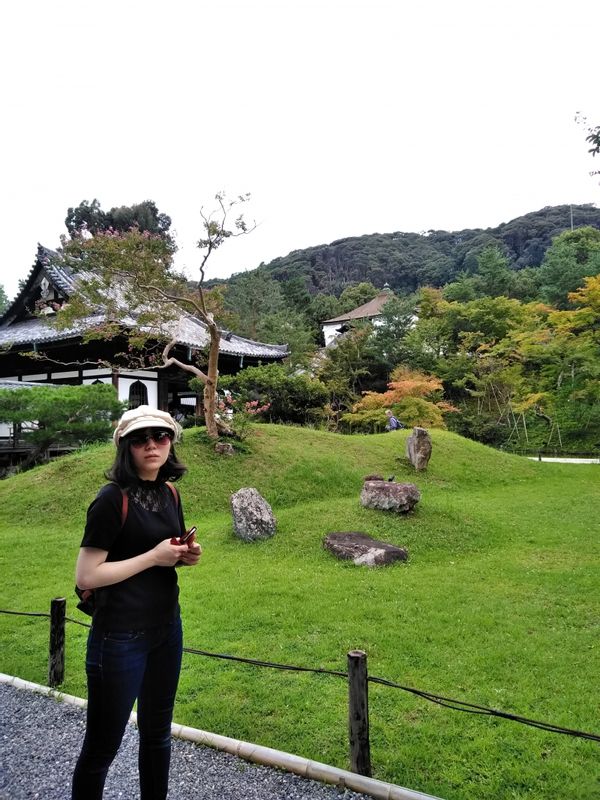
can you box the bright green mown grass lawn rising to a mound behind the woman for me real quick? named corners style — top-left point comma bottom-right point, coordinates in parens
top-left (0, 425), bottom-right (600, 800)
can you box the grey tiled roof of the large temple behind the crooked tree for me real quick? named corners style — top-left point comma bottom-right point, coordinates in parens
top-left (0, 245), bottom-right (288, 359)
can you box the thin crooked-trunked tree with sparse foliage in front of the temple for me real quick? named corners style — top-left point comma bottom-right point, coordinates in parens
top-left (57, 193), bottom-right (255, 438)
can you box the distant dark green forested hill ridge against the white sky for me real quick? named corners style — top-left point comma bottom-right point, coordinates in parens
top-left (221, 204), bottom-right (600, 297)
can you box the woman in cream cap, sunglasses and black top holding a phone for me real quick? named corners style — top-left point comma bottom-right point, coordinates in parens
top-left (72, 406), bottom-right (201, 800)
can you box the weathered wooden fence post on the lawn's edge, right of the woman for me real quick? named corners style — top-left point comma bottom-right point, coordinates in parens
top-left (348, 650), bottom-right (371, 778)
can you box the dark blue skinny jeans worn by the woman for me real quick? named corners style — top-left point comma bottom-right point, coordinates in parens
top-left (72, 620), bottom-right (183, 800)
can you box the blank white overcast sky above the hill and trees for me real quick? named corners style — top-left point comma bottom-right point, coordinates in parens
top-left (0, 0), bottom-right (600, 296)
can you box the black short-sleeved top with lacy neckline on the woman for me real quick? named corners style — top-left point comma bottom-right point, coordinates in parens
top-left (81, 481), bottom-right (185, 631)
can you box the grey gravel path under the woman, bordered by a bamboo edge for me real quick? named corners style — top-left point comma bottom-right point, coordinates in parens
top-left (0, 684), bottom-right (372, 800)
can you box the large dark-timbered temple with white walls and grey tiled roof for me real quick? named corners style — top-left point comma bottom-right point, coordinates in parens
top-left (0, 245), bottom-right (288, 413)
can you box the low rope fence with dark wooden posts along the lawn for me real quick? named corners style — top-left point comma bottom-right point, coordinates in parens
top-left (0, 598), bottom-right (600, 776)
